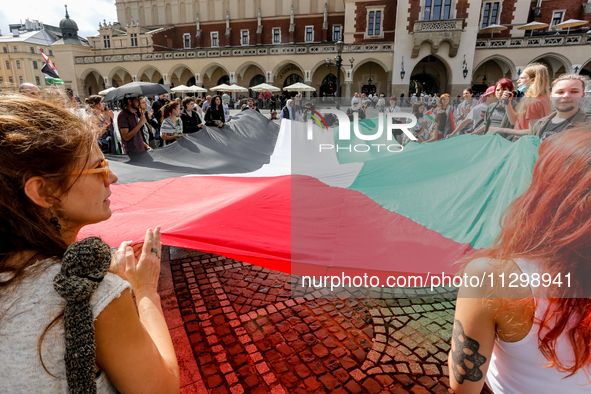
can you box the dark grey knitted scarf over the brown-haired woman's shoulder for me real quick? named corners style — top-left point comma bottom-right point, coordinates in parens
top-left (53, 237), bottom-right (111, 394)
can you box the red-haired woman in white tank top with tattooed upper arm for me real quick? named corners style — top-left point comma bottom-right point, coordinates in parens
top-left (449, 125), bottom-right (591, 394)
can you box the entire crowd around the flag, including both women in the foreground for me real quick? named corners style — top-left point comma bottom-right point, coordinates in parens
top-left (0, 64), bottom-right (591, 394)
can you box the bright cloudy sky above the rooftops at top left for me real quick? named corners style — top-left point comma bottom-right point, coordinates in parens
top-left (0, 0), bottom-right (117, 37)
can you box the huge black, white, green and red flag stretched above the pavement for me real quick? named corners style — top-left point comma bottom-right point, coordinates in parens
top-left (81, 111), bottom-right (539, 283)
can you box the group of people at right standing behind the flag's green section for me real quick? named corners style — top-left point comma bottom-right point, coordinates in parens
top-left (404, 64), bottom-right (591, 146)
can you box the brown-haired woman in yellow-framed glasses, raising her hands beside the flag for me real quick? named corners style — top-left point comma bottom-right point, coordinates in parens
top-left (0, 96), bottom-right (180, 393)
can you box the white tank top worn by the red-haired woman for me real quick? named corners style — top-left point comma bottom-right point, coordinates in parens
top-left (486, 259), bottom-right (591, 394)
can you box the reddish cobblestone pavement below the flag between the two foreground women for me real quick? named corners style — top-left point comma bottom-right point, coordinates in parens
top-left (163, 248), bottom-right (494, 394)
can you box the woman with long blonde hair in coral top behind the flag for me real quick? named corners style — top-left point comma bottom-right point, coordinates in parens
top-left (489, 63), bottom-right (551, 136)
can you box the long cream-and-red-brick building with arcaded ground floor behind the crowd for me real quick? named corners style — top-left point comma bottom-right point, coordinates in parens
top-left (13, 0), bottom-right (591, 97)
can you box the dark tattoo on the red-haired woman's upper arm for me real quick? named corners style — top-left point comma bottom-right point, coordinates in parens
top-left (451, 319), bottom-right (486, 384)
